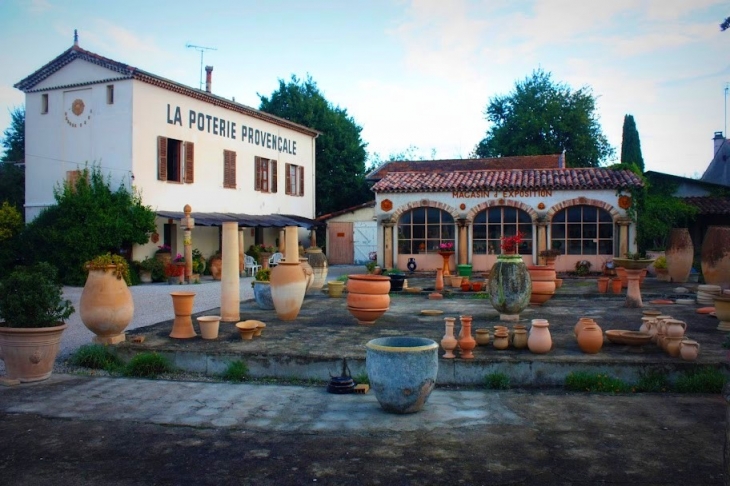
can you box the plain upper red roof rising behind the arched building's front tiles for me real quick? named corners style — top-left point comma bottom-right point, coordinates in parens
top-left (367, 154), bottom-right (562, 180)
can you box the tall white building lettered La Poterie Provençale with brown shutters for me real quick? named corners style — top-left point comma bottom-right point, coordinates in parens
top-left (15, 38), bottom-right (318, 259)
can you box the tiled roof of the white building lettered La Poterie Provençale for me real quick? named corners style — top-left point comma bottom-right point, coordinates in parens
top-left (15, 45), bottom-right (320, 136)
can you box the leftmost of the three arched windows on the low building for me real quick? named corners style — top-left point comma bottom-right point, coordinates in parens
top-left (398, 208), bottom-right (455, 253)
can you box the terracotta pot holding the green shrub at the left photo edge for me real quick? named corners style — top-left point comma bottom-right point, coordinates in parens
top-left (0, 324), bottom-right (67, 383)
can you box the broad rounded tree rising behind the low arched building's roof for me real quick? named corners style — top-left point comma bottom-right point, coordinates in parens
top-left (474, 69), bottom-right (614, 167)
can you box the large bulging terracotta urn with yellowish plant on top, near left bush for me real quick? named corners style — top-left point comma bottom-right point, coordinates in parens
top-left (79, 265), bottom-right (134, 344)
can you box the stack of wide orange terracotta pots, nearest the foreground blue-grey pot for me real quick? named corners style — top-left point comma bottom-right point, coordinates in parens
top-left (347, 274), bottom-right (390, 325)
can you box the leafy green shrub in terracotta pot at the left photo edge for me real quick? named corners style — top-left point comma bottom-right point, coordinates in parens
top-left (0, 262), bottom-right (74, 382)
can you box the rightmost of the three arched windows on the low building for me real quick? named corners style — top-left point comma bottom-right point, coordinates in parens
top-left (550, 206), bottom-right (613, 255)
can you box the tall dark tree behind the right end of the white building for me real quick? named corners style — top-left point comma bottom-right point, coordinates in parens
top-left (258, 75), bottom-right (373, 215)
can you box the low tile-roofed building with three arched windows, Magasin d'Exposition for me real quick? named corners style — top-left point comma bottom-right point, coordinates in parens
top-left (368, 158), bottom-right (643, 271)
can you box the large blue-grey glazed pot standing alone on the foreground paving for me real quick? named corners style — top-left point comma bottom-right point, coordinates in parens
top-left (365, 337), bottom-right (438, 413)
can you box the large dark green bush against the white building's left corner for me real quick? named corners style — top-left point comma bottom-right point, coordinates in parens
top-left (21, 166), bottom-right (155, 285)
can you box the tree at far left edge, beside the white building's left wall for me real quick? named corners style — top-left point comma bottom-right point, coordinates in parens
top-left (0, 108), bottom-right (25, 213)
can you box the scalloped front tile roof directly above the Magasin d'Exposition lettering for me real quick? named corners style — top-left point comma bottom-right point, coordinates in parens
top-left (372, 168), bottom-right (643, 192)
